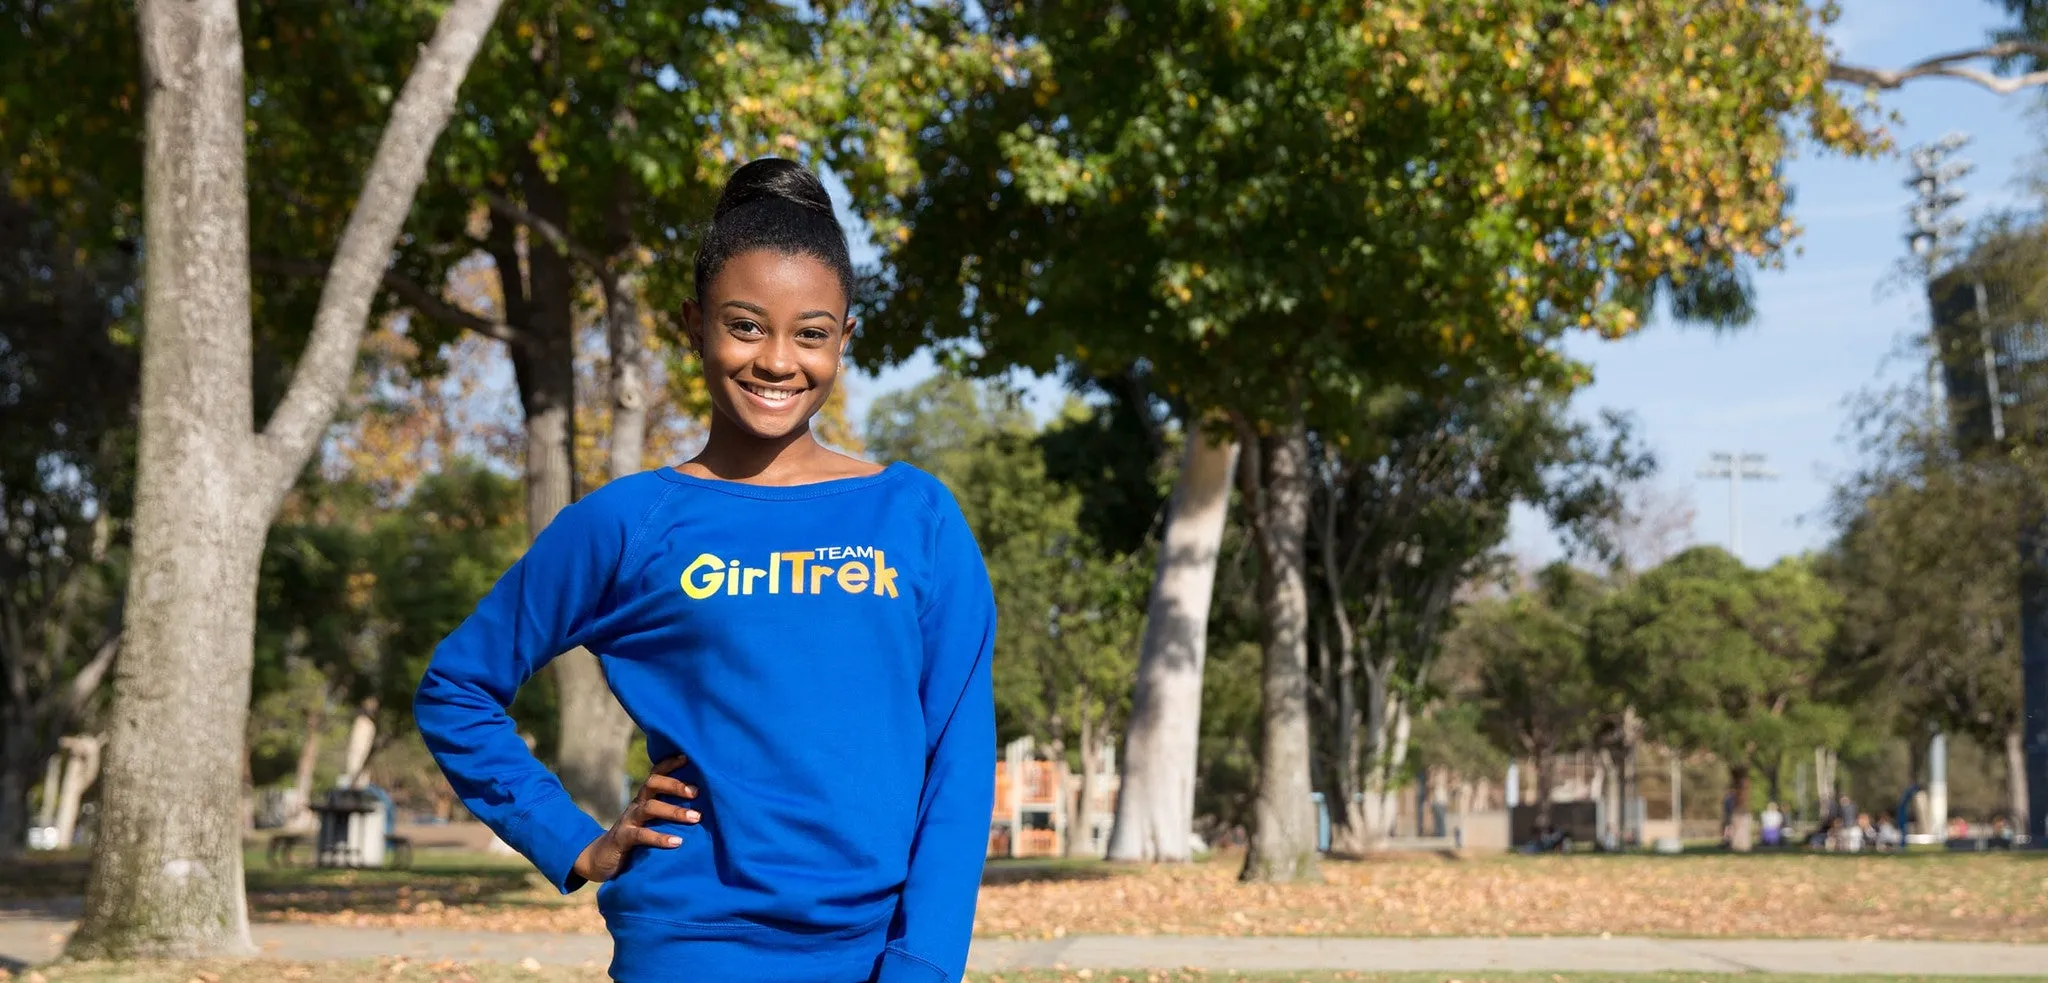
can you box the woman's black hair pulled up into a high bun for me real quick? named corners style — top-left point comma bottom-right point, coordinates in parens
top-left (696, 158), bottom-right (854, 303)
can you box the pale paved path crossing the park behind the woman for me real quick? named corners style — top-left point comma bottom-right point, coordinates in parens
top-left (0, 909), bottom-right (2048, 977)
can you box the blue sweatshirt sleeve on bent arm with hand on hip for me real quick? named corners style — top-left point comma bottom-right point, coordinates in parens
top-left (412, 489), bottom-right (629, 893)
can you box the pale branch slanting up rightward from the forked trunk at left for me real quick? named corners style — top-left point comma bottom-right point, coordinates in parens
top-left (258, 0), bottom-right (500, 516)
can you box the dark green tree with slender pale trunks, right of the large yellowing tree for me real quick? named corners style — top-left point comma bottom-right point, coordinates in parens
top-left (1309, 379), bottom-right (1655, 852)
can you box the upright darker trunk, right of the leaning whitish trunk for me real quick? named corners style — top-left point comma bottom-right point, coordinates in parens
top-left (1239, 418), bottom-right (1319, 883)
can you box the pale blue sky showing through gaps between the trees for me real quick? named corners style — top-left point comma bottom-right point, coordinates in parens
top-left (850, 0), bottom-right (2042, 563)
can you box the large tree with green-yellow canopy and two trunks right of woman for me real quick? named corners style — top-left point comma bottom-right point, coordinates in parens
top-left (868, 0), bottom-right (1866, 879)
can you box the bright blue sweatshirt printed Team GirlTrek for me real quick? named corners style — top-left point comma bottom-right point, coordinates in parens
top-left (414, 465), bottom-right (995, 983)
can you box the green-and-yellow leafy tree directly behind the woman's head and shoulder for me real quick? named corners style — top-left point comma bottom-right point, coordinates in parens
top-left (282, 0), bottom-right (1032, 819)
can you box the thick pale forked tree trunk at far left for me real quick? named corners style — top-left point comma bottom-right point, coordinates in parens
top-left (66, 0), bottom-right (498, 958)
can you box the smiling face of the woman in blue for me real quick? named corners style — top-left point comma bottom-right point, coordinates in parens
top-left (682, 250), bottom-right (854, 440)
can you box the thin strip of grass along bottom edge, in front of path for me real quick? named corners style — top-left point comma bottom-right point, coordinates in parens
top-left (0, 958), bottom-right (2039, 983)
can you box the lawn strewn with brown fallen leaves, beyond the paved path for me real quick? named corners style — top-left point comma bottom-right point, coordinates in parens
top-left (12, 852), bottom-right (2048, 946)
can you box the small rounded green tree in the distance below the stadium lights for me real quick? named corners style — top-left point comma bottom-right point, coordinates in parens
top-left (1591, 547), bottom-right (1847, 850)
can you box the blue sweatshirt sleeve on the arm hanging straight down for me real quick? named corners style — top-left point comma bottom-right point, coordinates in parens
top-left (877, 496), bottom-right (995, 983)
